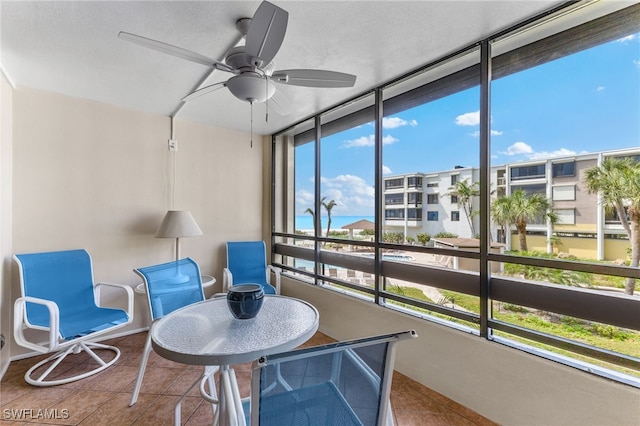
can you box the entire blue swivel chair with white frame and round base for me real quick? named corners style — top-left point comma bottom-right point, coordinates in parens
top-left (13, 250), bottom-right (133, 386)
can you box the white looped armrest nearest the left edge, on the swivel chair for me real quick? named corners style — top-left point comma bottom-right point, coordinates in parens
top-left (13, 296), bottom-right (60, 353)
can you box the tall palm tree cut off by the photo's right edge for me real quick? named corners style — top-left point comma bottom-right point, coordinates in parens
top-left (584, 158), bottom-right (640, 294)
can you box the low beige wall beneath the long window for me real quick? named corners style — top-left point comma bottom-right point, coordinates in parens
top-left (283, 278), bottom-right (640, 426)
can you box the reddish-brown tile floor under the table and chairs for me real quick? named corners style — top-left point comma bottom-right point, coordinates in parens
top-left (0, 332), bottom-right (495, 426)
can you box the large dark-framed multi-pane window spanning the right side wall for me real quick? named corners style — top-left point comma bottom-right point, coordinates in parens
top-left (273, 2), bottom-right (640, 387)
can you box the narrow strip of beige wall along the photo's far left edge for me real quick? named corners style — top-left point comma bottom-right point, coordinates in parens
top-left (0, 72), bottom-right (13, 376)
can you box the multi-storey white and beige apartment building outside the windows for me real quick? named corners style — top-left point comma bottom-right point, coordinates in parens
top-left (384, 148), bottom-right (640, 260)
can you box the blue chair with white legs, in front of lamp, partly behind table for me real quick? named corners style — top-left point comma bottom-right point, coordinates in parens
top-left (129, 258), bottom-right (218, 424)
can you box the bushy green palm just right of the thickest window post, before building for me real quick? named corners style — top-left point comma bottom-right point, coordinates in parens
top-left (491, 189), bottom-right (558, 251)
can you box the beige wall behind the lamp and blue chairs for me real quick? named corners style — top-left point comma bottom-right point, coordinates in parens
top-left (8, 88), bottom-right (263, 357)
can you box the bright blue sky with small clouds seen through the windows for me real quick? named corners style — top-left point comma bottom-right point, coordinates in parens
top-left (296, 34), bottom-right (640, 216)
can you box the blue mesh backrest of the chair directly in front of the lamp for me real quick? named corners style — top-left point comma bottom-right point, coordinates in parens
top-left (134, 257), bottom-right (204, 320)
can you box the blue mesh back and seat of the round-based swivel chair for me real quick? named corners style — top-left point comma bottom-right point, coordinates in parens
top-left (15, 249), bottom-right (129, 339)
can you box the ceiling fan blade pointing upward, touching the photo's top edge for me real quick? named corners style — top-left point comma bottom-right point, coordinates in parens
top-left (245, 1), bottom-right (289, 67)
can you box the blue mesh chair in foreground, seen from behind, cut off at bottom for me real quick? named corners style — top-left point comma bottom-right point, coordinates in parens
top-left (243, 330), bottom-right (417, 426)
